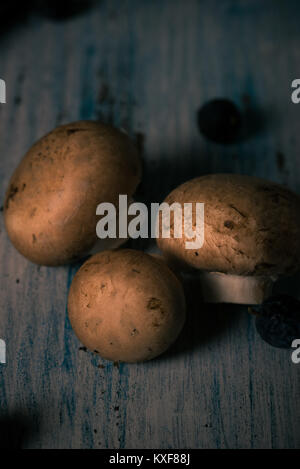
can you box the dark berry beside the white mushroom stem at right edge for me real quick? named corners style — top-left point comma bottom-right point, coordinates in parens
top-left (251, 295), bottom-right (300, 348)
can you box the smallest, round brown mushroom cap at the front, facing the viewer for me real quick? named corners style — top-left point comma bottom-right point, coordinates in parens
top-left (68, 249), bottom-right (185, 362)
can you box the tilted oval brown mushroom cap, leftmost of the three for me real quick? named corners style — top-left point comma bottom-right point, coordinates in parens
top-left (4, 121), bottom-right (141, 265)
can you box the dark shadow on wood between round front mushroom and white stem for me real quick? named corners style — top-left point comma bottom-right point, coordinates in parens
top-left (157, 277), bottom-right (247, 361)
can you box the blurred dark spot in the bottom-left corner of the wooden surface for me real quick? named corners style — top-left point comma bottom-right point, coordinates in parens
top-left (0, 409), bottom-right (38, 449)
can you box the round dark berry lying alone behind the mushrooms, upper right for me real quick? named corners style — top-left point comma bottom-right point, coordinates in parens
top-left (198, 98), bottom-right (242, 143)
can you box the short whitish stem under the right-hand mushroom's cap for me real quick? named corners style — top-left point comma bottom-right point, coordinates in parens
top-left (200, 272), bottom-right (276, 305)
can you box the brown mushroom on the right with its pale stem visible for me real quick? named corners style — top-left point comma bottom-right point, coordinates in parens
top-left (158, 174), bottom-right (300, 304)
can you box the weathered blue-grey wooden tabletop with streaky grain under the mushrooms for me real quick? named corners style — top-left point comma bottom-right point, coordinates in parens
top-left (0, 0), bottom-right (300, 448)
